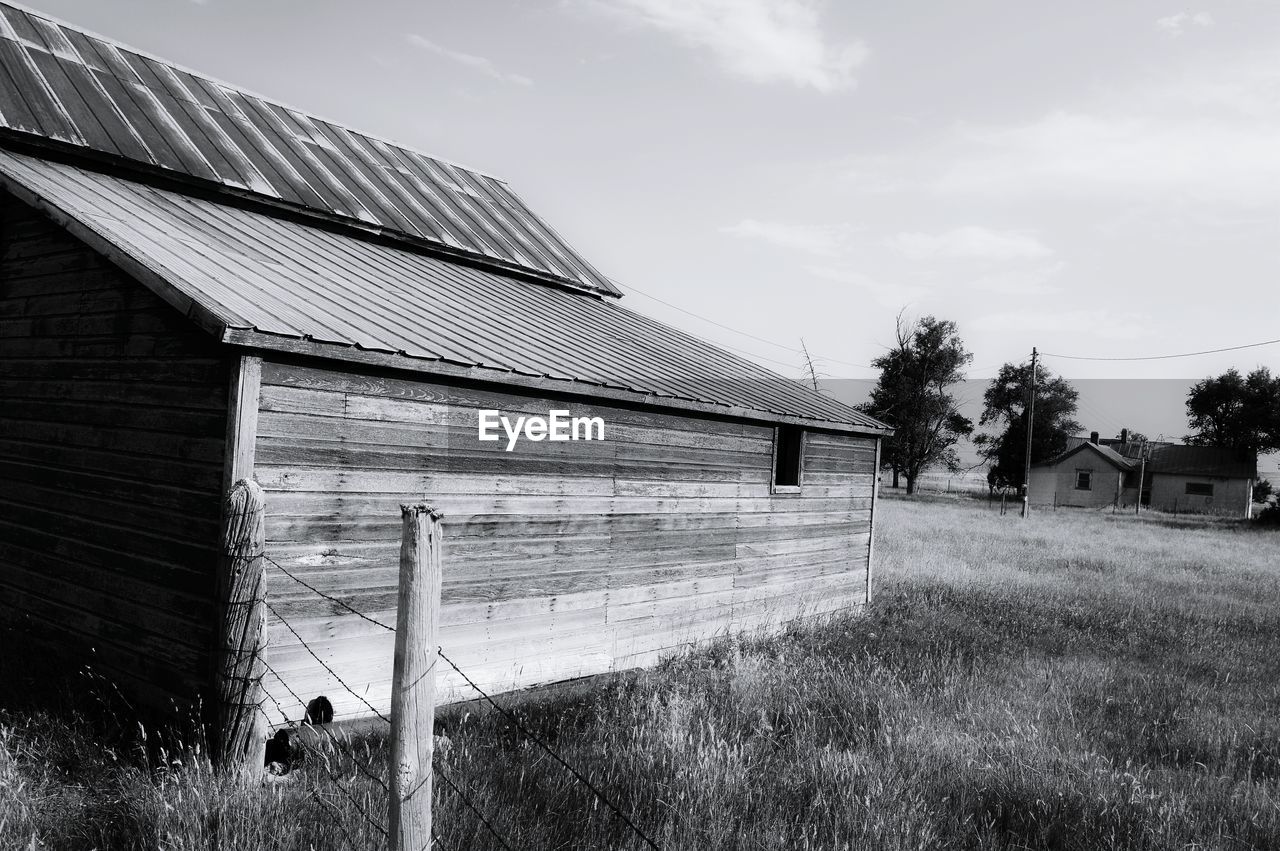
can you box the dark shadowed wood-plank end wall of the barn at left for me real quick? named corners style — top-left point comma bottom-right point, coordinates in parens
top-left (0, 195), bottom-right (228, 705)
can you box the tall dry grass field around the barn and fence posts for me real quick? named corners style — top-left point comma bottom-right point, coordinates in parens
top-left (0, 499), bottom-right (1280, 851)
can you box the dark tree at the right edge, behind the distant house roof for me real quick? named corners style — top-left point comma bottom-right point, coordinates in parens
top-left (1185, 366), bottom-right (1280, 453)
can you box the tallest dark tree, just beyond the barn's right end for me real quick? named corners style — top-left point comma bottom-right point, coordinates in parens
top-left (861, 314), bottom-right (973, 494)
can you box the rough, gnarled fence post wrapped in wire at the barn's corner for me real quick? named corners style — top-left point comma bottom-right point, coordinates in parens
top-left (215, 479), bottom-right (266, 774)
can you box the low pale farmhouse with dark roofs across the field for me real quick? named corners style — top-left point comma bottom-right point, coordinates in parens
top-left (1029, 431), bottom-right (1258, 517)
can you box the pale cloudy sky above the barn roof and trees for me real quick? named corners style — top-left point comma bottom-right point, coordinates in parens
top-left (33, 0), bottom-right (1280, 445)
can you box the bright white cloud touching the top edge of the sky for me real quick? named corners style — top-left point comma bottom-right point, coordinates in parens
top-left (593, 0), bottom-right (868, 93)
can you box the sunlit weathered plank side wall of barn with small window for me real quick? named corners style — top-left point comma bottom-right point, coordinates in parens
top-left (256, 362), bottom-right (876, 722)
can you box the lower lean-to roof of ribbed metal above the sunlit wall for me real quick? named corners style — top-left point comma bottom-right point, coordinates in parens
top-left (0, 145), bottom-right (886, 431)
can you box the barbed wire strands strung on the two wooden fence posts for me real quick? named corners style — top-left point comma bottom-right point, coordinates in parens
top-left (227, 491), bottom-right (659, 851)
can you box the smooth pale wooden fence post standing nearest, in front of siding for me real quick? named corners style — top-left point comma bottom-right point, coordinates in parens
top-left (388, 505), bottom-right (440, 851)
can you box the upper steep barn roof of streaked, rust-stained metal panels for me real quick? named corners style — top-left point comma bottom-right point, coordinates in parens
top-left (0, 3), bottom-right (621, 296)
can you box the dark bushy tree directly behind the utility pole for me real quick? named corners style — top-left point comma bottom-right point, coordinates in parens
top-left (974, 363), bottom-right (1082, 488)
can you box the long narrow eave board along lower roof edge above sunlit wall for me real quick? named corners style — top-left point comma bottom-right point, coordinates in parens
top-left (219, 328), bottom-right (893, 438)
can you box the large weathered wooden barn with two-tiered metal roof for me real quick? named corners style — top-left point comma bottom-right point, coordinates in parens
top-left (0, 3), bottom-right (887, 722)
